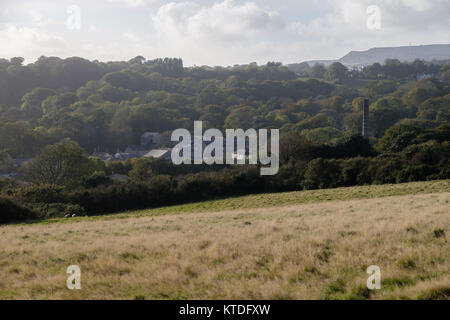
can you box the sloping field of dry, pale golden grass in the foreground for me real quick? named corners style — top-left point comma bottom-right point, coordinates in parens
top-left (0, 181), bottom-right (450, 299)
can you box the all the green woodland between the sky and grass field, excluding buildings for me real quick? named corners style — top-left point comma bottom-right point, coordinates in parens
top-left (0, 56), bottom-right (450, 217)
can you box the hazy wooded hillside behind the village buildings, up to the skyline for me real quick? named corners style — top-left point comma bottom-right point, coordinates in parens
top-left (5, 56), bottom-right (442, 158)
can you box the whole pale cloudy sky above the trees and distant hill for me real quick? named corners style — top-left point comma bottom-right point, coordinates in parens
top-left (0, 0), bottom-right (450, 66)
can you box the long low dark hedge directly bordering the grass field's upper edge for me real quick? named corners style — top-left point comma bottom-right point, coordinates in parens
top-left (4, 151), bottom-right (450, 221)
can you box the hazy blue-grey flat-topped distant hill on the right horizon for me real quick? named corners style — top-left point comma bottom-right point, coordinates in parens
top-left (288, 44), bottom-right (450, 72)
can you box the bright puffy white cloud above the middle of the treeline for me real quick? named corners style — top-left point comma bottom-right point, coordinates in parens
top-left (152, 0), bottom-right (285, 65)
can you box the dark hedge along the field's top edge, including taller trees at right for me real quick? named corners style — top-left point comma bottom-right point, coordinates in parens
top-left (5, 131), bottom-right (450, 221)
